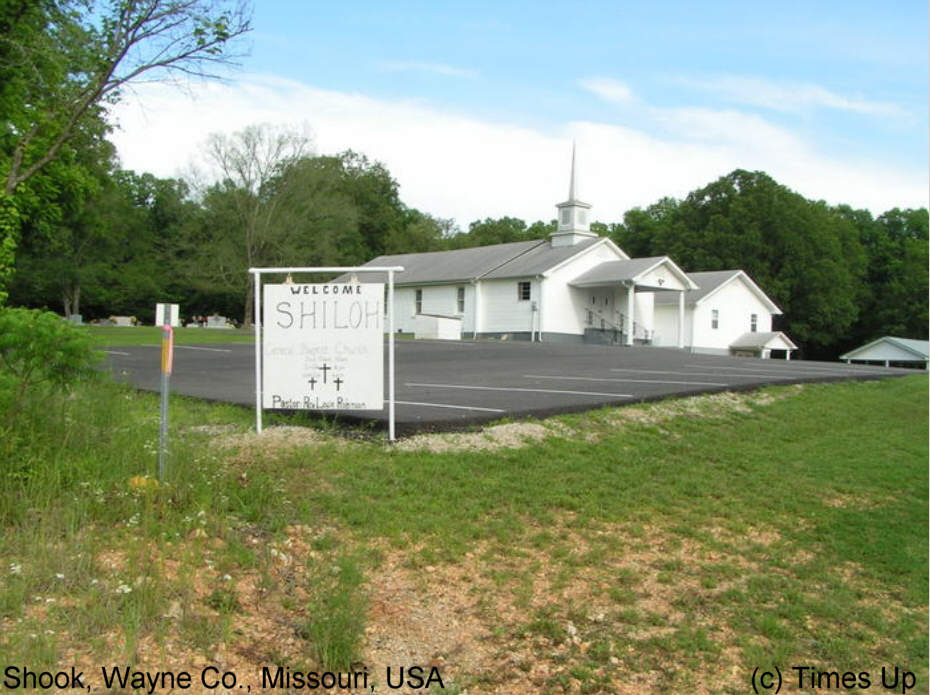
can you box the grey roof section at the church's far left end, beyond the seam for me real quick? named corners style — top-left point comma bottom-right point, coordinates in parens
top-left (350, 239), bottom-right (549, 285)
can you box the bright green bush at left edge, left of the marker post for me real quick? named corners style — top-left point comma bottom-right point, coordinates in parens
top-left (0, 308), bottom-right (100, 424)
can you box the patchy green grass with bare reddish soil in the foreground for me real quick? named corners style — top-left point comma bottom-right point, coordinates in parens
top-left (0, 375), bottom-right (928, 694)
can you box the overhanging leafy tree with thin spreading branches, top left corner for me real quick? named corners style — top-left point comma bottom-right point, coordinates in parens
top-left (0, 0), bottom-right (250, 301)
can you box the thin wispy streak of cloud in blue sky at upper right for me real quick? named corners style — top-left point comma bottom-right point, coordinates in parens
top-left (680, 75), bottom-right (906, 118)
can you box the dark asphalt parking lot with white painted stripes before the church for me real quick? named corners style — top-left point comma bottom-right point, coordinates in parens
top-left (106, 340), bottom-right (915, 435)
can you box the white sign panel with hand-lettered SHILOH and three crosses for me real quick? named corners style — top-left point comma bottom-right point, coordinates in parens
top-left (262, 283), bottom-right (384, 410)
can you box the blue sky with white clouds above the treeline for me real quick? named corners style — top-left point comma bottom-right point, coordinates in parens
top-left (111, 0), bottom-right (930, 229)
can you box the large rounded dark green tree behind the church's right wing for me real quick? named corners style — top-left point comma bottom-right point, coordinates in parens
top-left (615, 170), bottom-right (866, 357)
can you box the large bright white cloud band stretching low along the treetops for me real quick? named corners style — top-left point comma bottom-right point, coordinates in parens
top-left (107, 75), bottom-right (928, 227)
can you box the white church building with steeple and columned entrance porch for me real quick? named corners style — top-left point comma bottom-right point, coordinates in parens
top-left (356, 151), bottom-right (796, 357)
